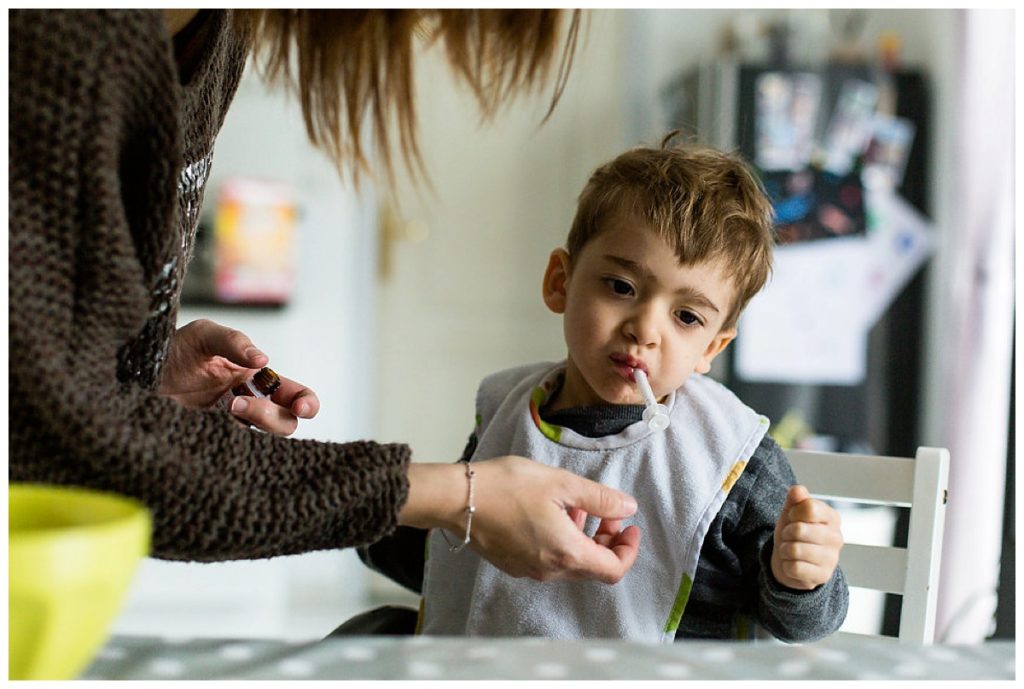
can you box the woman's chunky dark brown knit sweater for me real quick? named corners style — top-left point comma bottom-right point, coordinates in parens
top-left (8, 10), bottom-right (410, 560)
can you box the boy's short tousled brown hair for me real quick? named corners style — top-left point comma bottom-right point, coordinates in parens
top-left (566, 134), bottom-right (775, 329)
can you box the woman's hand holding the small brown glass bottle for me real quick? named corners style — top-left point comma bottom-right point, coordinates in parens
top-left (159, 318), bottom-right (319, 435)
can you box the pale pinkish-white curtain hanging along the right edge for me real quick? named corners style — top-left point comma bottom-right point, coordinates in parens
top-left (936, 10), bottom-right (1015, 643)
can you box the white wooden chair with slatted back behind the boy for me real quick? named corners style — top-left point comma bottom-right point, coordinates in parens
top-left (785, 447), bottom-right (949, 644)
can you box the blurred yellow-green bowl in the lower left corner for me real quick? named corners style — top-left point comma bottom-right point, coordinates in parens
top-left (7, 483), bottom-right (151, 680)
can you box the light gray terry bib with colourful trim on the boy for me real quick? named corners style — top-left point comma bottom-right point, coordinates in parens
top-left (421, 362), bottom-right (768, 642)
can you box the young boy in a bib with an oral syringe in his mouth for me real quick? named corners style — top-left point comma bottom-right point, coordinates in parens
top-left (361, 137), bottom-right (848, 641)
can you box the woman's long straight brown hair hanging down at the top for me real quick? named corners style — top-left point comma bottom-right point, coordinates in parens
top-left (236, 9), bottom-right (581, 181)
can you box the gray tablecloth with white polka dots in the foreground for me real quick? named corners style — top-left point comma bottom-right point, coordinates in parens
top-left (81, 636), bottom-right (1015, 680)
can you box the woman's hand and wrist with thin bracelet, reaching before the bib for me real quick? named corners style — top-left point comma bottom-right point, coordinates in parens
top-left (399, 457), bottom-right (640, 584)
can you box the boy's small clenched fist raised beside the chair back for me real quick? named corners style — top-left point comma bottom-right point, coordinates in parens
top-left (771, 485), bottom-right (843, 591)
